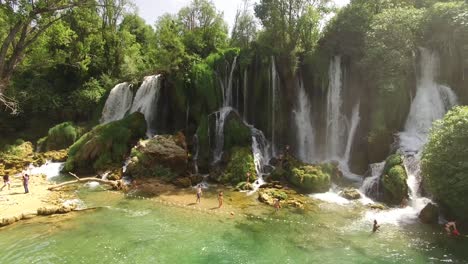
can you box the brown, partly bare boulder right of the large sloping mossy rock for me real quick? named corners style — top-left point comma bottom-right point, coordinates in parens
top-left (127, 133), bottom-right (188, 179)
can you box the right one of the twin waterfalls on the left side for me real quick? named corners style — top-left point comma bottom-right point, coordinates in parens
top-left (130, 75), bottom-right (161, 137)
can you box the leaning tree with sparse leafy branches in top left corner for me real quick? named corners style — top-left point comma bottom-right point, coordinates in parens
top-left (0, 0), bottom-right (89, 113)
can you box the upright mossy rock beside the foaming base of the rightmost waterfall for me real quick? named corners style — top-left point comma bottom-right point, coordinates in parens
top-left (380, 154), bottom-right (408, 205)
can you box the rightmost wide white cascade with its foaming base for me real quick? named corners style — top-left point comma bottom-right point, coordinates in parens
top-left (362, 48), bottom-right (457, 225)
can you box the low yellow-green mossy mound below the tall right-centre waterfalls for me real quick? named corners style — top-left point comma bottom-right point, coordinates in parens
top-left (288, 165), bottom-right (331, 192)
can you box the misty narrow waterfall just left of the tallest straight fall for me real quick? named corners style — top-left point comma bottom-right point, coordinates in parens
top-left (293, 76), bottom-right (315, 163)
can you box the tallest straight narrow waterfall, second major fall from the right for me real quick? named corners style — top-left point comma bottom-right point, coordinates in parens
top-left (326, 56), bottom-right (346, 160)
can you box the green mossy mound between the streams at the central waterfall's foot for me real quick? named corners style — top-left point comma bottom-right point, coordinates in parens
top-left (221, 147), bottom-right (257, 185)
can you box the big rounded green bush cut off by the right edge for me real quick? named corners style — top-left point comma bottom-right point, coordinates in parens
top-left (422, 106), bottom-right (468, 219)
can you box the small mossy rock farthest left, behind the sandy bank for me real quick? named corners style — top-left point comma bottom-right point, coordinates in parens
top-left (37, 122), bottom-right (80, 151)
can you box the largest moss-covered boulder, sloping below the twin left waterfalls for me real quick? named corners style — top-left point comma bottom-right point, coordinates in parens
top-left (64, 113), bottom-right (146, 173)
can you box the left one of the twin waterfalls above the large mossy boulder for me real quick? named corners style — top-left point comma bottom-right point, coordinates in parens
top-left (100, 82), bottom-right (133, 124)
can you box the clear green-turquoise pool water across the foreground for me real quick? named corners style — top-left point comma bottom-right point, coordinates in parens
top-left (0, 192), bottom-right (468, 263)
